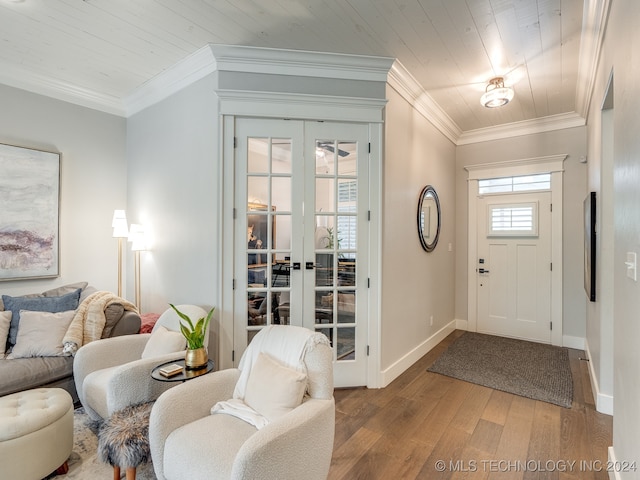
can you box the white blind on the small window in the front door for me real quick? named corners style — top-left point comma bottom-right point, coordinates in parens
top-left (487, 202), bottom-right (538, 237)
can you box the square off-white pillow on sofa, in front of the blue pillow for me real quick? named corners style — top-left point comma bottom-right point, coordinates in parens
top-left (7, 310), bottom-right (76, 358)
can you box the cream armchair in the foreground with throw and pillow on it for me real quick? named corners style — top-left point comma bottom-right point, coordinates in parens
top-left (149, 325), bottom-right (335, 480)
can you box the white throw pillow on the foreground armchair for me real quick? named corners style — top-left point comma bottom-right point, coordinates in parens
top-left (244, 353), bottom-right (307, 421)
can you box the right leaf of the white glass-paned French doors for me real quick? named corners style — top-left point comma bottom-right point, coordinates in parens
top-left (303, 122), bottom-right (369, 386)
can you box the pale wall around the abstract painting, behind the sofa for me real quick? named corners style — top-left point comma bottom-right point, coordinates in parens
top-left (0, 85), bottom-right (127, 295)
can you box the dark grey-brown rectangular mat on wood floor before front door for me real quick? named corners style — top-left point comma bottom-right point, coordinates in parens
top-left (427, 332), bottom-right (573, 408)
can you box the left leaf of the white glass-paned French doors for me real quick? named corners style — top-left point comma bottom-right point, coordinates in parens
top-left (234, 119), bottom-right (303, 353)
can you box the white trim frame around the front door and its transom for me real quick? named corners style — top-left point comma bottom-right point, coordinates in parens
top-left (464, 154), bottom-right (567, 346)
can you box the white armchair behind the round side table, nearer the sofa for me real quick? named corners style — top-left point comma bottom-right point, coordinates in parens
top-left (73, 305), bottom-right (209, 420)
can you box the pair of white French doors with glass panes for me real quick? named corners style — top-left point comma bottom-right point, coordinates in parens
top-left (234, 118), bottom-right (369, 386)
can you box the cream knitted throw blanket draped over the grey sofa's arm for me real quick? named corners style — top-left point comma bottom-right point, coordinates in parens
top-left (62, 291), bottom-right (138, 355)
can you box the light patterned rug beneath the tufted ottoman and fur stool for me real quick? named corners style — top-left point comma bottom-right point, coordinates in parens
top-left (48, 408), bottom-right (156, 480)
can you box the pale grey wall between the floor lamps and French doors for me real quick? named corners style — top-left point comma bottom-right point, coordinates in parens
top-left (127, 77), bottom-right (221, 357)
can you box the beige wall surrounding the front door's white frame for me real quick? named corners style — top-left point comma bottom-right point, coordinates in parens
top-left (455, 125), bottom-right (587, 342)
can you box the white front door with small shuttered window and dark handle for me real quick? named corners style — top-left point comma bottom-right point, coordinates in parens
top-left (476, 192), bottom-right (552, 343)
